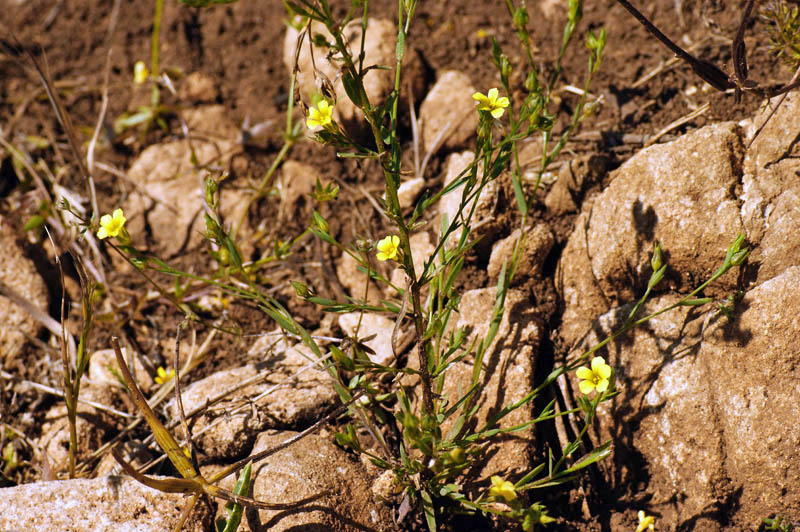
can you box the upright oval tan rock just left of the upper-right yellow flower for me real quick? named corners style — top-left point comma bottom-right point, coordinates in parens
top-left (419, 70), bottom-right (478, 154)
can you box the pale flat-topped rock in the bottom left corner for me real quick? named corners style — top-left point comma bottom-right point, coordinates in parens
top-left (0, 476), bottom-right (214, 532)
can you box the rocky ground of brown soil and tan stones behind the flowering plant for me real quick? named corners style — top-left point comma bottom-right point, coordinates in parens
top-left (0, 0), bottom-right (800, 531)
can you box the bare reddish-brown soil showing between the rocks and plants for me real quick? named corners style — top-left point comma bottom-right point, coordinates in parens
top-left (0, 0), bottom-right (791, 530)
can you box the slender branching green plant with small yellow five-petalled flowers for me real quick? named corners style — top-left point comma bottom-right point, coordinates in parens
top-left (90, 0), bottom-right (748, 530)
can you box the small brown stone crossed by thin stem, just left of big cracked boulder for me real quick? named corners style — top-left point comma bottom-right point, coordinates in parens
top-left (486, 224), bottom-right (555, 283)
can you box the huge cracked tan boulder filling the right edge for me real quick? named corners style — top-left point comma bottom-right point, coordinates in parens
top-left (558, 94), bottom-right (800, 531)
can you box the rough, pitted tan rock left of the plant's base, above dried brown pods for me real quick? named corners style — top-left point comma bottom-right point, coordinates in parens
top-left (171, 335), bottom-right (336, 460)
